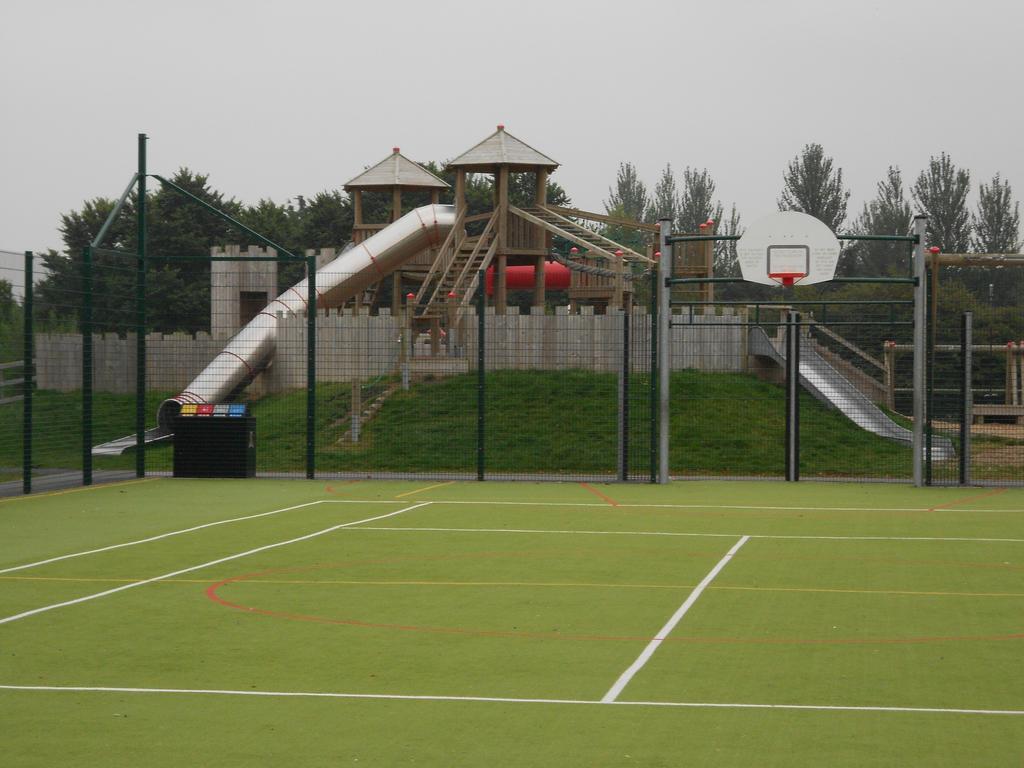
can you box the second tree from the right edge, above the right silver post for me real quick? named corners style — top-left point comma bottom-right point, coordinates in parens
top-left (910, 153), bottom-right (971, 253)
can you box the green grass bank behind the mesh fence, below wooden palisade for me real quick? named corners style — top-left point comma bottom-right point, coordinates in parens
top-left (0, 371), bottom-right (1021, 480)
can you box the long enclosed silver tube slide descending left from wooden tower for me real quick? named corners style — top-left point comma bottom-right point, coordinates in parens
top-left (92, 205), bottom-right (455, 456)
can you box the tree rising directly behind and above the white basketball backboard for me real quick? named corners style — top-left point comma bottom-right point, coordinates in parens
top-left (778, 143), bottom-right (850, 231)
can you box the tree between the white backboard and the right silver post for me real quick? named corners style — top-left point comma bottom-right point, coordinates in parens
top-left (840, 166), bottom-right (913, 278)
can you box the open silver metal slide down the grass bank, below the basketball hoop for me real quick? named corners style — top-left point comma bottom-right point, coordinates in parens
top-left (748, 328), bottom-right (956, 461)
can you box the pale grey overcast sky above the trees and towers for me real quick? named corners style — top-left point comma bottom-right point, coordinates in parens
top-left (0, 0), bottom-right (1024, 284)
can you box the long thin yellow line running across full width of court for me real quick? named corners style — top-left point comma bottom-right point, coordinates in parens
top-left (0, 575), bottom-right (1024, 597)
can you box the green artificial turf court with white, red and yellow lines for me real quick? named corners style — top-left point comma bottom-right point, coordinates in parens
top-left (0, 479), bottom-right (1024, 766)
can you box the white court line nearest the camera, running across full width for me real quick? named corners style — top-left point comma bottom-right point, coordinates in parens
top-left (0, 685), bottom-right (1024, 716)
